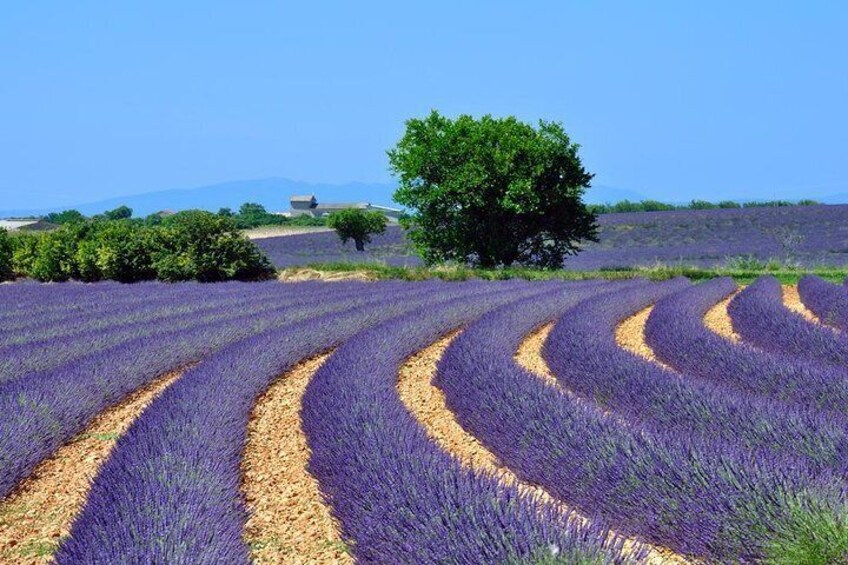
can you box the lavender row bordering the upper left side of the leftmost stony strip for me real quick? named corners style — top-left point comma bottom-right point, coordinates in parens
top-left (0, 283), bottom-right (424, 497)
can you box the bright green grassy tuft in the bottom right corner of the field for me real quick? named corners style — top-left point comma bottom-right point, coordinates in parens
top-left (765, 501), bottom-right (848, 565)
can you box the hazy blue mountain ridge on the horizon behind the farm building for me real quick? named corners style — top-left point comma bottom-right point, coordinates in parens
top-left (0, 178), bottom-right (645, 218)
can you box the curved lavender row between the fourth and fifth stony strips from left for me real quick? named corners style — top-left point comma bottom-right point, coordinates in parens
top-left (542, 283), bottom-right (848, 474)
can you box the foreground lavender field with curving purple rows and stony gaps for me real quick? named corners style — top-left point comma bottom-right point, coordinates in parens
top-left (0, 276), bottom-right (848, 564)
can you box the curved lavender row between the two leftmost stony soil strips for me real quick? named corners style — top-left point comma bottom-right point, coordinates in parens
top-left (56, 283), bottom-right (548, 563)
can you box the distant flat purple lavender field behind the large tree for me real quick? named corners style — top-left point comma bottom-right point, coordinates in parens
top-left (256, 205), bottom-right (848, 270)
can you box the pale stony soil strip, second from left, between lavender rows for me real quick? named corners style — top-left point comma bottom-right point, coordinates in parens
top-left (242, 355), bottom-right (352, 564)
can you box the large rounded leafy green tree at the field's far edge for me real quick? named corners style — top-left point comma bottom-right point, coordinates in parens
top-left (388, 111), bottom-right (597, 268)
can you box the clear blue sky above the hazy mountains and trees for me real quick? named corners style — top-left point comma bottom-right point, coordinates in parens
top-left (0, 0), bottom-right (848, 208)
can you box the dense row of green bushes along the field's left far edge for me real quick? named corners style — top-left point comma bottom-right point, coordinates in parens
top-left (10, 211), bottom-right (274, 282)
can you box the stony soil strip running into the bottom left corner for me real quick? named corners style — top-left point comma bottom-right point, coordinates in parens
top-left (0, 372), bottom-right (182, 563)
